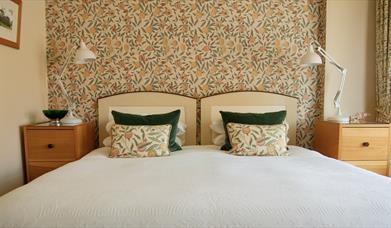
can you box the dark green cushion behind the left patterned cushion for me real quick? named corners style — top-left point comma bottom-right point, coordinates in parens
top-left (111, 109), bottom-right (182, 152)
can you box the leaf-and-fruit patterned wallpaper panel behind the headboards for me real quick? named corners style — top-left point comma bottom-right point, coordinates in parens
top-left (47, 0), bottom-right (326, 147)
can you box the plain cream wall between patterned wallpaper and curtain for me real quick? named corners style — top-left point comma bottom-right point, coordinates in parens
top-left (324, 0), bottom-right (376, 118)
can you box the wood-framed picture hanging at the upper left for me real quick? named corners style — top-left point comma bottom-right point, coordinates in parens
top-left (0, 0), bottom-right (22, 49)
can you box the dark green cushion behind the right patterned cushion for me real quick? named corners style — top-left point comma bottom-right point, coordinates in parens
top-left (220, 111), bottom-right (286, 150)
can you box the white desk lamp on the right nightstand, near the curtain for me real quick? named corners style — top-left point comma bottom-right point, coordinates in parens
top-left (301, 45), bottom-right (349, 123)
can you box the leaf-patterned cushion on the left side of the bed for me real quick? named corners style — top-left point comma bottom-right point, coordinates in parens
top-left (109, 124), bottom-right (171, 158)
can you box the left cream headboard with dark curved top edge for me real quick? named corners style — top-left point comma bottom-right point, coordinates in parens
top-left (98, 92), bottom-right (197, 146)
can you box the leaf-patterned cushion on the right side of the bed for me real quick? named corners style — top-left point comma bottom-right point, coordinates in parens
top-left (227, 123), bottom-right (288, 156)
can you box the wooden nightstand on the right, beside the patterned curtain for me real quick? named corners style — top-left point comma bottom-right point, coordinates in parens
top-left (314, 121), bottom-right (390, 176)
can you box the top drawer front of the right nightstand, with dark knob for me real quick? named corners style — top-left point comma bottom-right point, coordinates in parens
top-left (339, 128), bottom-right (389, 161)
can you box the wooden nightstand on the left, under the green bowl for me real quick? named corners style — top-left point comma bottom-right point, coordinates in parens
top-left (23, 123), bottom-right (94, 182)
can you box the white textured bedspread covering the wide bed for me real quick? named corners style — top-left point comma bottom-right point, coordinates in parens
top-left (0, 147), bottom-right (391, 227)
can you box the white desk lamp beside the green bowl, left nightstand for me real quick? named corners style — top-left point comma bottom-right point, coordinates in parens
top-left (56, 41), bottom-right (96, 125)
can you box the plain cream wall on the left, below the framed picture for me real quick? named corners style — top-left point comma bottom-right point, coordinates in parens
top-left (0, 0), bottom-right (47, 195)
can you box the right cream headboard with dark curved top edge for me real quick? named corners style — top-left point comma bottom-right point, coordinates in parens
top-left (201, 92), bottom-right (297, 145)
